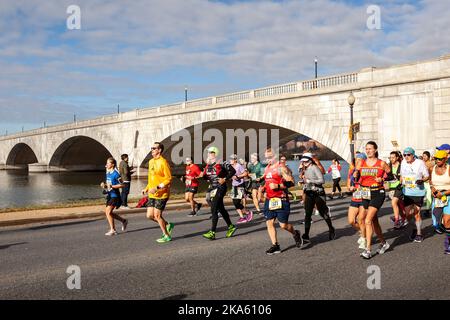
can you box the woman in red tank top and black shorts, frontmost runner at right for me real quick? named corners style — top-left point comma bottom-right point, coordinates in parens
top-left (354, 141), bottom-right (390, 259)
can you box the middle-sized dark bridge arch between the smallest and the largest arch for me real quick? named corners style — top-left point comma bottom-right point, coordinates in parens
top-left (49, 136), bottom-right (111, 171)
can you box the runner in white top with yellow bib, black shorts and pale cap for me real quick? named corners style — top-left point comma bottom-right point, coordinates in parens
top-left (400, 147), bottom-right (430, 242)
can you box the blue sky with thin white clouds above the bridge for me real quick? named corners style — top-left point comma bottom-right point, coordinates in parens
top-left (0, 0), bottom-right (450, 134)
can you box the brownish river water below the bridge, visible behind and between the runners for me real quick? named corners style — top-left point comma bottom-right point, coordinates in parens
top-left (0, 161), bottom-right (348, 209)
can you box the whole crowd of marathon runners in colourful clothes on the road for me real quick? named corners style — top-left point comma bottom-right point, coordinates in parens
top-left (102, 141), bottom-right (450, 259)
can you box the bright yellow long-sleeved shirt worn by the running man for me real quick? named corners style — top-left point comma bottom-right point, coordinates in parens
top-left (146, 156), bottom-right (172, 199)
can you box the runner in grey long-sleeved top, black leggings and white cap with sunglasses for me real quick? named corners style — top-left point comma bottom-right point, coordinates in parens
top-left (300, 155), bottom-right (336, 245)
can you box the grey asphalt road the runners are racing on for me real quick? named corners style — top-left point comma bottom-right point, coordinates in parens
top-left (0, 198), bottom-right (450, 300)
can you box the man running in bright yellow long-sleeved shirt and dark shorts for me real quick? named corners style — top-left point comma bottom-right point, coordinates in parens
top-left (142, 142), bottom-right (174, 243)
